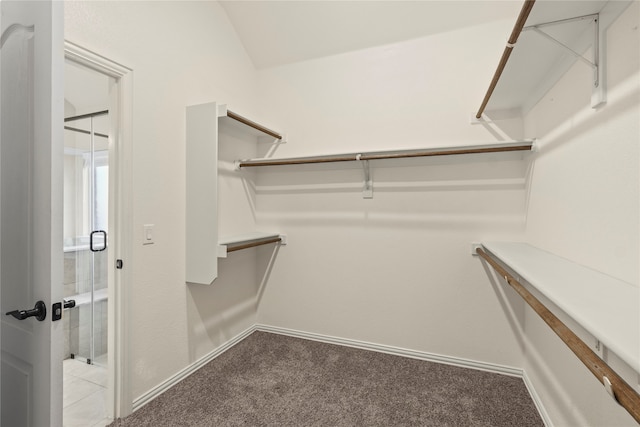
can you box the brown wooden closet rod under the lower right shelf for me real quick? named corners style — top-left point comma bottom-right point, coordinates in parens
top-left (476, 248), bottom-right (640, 423)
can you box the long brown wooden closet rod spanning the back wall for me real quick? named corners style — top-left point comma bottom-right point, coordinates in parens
top-left (238, 141), bottom-right (533, 168)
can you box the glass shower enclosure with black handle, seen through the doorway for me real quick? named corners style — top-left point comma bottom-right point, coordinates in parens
top-left (64, 111), bottom-right (109, 365)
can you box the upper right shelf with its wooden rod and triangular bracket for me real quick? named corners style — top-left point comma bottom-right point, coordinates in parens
top-left (472, 0), bottom-right (632, 123)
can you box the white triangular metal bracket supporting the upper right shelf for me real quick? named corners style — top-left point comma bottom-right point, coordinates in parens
top-left (522, 13), bottom-right (606, 108)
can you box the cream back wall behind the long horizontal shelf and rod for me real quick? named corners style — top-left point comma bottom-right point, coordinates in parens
top-left (256, 18), bottom-right (527, 366)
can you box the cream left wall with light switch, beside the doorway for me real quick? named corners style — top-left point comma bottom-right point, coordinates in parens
top-left (65, 2), bottom-right (256, 400)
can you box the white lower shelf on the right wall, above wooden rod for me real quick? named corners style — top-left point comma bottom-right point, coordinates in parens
top-left (482, 242), bottom-right (640, 373)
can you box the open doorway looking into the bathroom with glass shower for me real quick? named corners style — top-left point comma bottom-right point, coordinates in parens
top-left (63, 59), bottom-right (115, 426)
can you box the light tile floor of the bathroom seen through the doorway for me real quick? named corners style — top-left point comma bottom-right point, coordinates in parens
top-left (62, 359), bottom-right (112, 427)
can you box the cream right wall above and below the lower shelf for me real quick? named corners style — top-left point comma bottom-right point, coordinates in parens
top-left (524, 2), bottom-right (640, 426)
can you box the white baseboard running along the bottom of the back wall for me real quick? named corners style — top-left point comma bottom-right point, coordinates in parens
top-left (256, 325), bottom-right (523, 378)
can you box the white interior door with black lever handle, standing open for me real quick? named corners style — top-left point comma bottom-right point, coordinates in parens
top-left (0, 0), bottom-right (64, 427)
